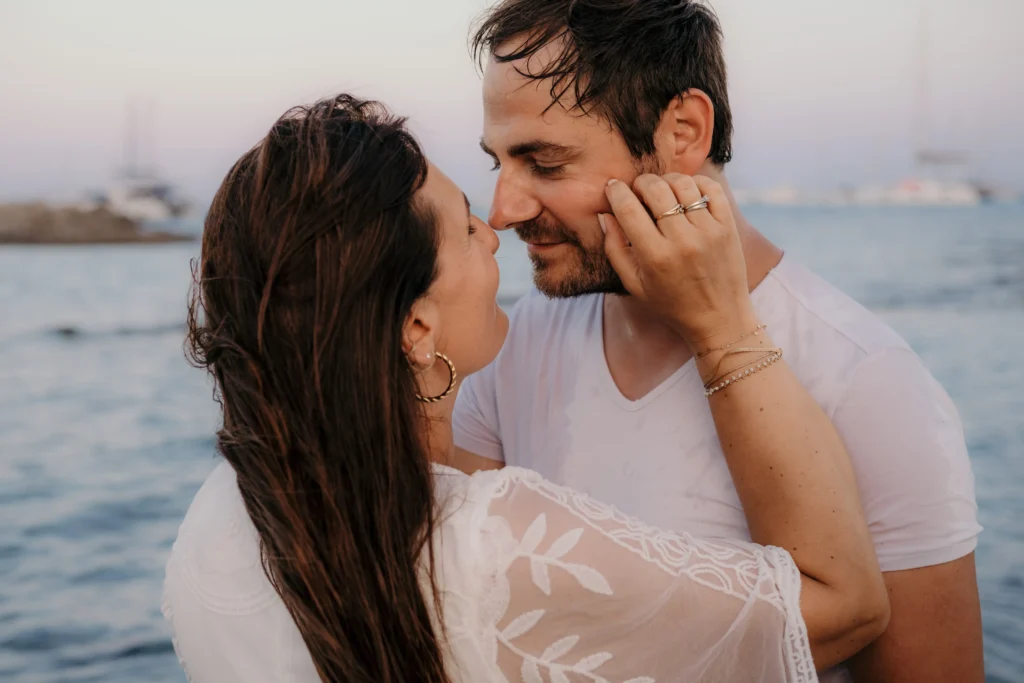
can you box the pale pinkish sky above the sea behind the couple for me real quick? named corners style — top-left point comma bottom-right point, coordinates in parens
top-left (0, 0), bottom-right (1024, 205)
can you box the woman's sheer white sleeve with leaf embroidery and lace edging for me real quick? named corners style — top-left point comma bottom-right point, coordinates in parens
top-left (472, 468), bottom-right (817, 683)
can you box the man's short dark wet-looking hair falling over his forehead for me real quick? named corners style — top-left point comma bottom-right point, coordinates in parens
top-left (471, 0), bottom-right (732, 166)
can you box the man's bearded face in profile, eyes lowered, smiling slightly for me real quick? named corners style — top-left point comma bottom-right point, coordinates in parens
top-left (481, 50), bottom-right (655, 297)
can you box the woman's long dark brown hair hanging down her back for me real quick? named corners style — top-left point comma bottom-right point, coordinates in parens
top-left (187, 95), bottom-right (447, 683)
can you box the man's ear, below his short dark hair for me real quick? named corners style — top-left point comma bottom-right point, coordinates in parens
top-left (655, 89), bottom-right (715, 175)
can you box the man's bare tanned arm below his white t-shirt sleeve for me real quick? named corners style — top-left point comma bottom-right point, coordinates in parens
top-left (849, 553), bottom-right (985, 683)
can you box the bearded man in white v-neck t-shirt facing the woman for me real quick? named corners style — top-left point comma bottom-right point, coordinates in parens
top-left (455, 0), bottom-right (983, 683)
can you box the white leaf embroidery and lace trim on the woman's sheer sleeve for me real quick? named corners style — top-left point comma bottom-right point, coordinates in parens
top-left (482, 469), bottom-right (817, 683)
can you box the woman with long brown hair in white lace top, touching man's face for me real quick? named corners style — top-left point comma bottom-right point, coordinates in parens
top-left (165, 95), bottom-right (888, 683)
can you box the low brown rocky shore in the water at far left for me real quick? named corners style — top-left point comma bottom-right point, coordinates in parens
top-left (0, 202), bottom-right (195, 245)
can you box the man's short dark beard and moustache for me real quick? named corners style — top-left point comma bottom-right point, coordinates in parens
top-left (515, 219), bottom-right (629, 298)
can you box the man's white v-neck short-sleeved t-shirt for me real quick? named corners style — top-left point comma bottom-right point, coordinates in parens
top-left (454, 256), bottom-right (981, 571)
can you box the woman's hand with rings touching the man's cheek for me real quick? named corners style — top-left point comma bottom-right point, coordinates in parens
top-left (598, 173), bottom-right (757, 353)
